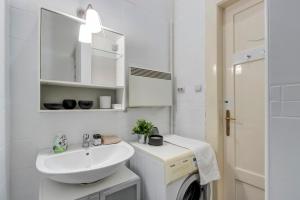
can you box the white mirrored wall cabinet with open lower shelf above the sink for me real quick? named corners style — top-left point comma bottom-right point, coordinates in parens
top-left (40, 8), bottom-right (126, 110)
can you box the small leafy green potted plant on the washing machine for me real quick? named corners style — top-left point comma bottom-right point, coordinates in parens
top-left (132, 119), bottom-right (154, 144)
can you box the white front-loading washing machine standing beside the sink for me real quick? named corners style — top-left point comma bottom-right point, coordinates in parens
top-left (130, 143), bottom-right (210, 200)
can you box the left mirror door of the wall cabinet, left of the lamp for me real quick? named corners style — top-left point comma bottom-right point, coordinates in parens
top-left (40, 9), bottom-right (87, 82)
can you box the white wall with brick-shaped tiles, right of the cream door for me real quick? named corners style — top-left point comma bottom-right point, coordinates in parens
top-left (268, 0), bottom-right (300, 200)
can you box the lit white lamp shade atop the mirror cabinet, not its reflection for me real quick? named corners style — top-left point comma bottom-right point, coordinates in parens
top-left (85, 8), bottom-right (102, 33)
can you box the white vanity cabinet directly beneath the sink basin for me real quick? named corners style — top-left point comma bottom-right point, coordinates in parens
top-left (39, 166), bottom-right (141, 200)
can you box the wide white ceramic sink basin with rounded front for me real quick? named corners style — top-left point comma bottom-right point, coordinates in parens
top-left (36, 142), bottom-right (134, 184)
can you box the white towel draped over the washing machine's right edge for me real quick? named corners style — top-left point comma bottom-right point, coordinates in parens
top-left (164, 135), bottom-right (220, 185)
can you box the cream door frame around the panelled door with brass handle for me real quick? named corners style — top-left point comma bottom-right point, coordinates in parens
top-left (205, 0), bottom-right (269, 200)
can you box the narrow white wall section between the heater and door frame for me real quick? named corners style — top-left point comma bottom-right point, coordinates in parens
top-left (174, 0), bottom-right (205, 140)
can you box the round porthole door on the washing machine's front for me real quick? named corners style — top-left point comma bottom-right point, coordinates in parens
top-left (176, 174), bottom-right (208, 200)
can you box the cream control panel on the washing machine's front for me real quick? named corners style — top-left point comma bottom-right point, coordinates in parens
top-left (165, 155), bottom-right (198, 184)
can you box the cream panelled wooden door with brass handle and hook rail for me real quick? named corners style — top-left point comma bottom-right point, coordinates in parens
top-left (223, 0), bottom-right (265, 200)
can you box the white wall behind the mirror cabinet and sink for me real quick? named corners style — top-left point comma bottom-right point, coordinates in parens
top-left (10, 0), bottom-right (170, 200)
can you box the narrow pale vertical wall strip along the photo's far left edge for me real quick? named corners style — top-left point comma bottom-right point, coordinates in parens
top-left (0, 1), bottom-right (9, 200)
